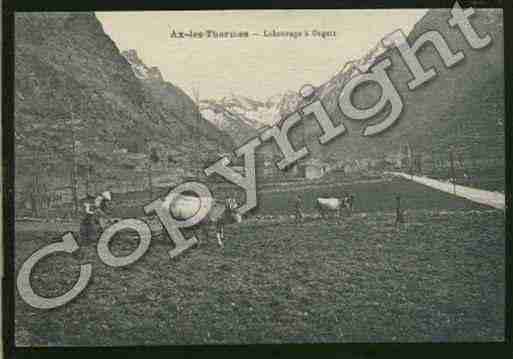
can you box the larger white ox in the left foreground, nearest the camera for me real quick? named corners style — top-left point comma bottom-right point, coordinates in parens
top-left (163, 195), bottom-right (242, 247)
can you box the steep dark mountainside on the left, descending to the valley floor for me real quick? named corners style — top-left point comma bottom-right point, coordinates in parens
top-left (14, 12), bottom-right (234, 195)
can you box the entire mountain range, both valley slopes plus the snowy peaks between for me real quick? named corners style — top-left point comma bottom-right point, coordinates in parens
top-left (14, 9), bottom-right (505, 202)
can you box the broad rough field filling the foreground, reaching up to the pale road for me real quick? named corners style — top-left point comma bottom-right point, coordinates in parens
top-left (15, 180), bottom-right (505, 346)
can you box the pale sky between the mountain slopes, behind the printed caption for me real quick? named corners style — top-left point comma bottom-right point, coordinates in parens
top-left (96, 9), bottom-right (427, 100)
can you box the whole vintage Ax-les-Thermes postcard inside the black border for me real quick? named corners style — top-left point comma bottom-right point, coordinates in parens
top-left (13, 1), bottom-right (506, 347)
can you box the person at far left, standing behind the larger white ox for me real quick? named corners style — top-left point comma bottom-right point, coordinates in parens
top-left (80, 191), bottom-right (112, 241)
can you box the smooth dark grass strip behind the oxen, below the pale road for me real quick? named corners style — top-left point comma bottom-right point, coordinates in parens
top-left (92, 178), bottom-right (486, 217)
